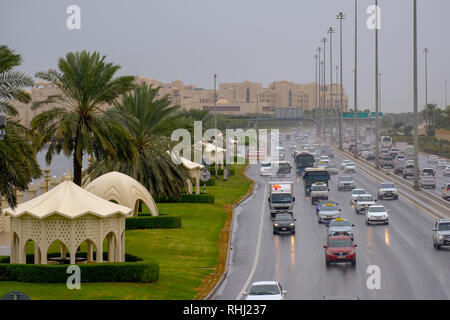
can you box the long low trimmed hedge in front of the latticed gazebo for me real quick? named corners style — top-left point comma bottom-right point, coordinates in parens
top-left (0, 262), bottom-right (159, 283)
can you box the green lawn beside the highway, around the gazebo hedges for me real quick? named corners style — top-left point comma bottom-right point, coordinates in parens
top-left (0, 165), bottom-right (250, 300)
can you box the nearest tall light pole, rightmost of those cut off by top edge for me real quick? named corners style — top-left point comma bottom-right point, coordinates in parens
top-left (413, 0), bottom-right (420, 190)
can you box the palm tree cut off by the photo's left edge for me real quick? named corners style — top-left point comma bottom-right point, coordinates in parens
top-left (0, 46), bottom-right (41, 207)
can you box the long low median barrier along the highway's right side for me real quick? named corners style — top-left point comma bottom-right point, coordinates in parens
top-left (332, 146), bottom-right (450, 218)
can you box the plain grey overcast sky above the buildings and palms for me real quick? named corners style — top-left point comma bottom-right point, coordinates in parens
top-left (0, 0), bottom-right (450, 112)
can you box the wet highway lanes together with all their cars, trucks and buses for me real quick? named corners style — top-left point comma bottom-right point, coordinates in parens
top-left (213, 129), bottom-right (450, 300)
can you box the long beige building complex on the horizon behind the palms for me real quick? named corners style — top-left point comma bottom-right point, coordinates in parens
top-left (15, 77), bottom-right (349, 126)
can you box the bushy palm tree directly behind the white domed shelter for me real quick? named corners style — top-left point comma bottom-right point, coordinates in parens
top-left (88, 83), bottom-right (191, 198)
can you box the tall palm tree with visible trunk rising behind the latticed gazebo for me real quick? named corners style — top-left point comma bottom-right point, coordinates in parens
top-left (31, 51), bottom-right (134, 185)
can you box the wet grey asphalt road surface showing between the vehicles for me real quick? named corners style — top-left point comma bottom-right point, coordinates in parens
top-left (213, 134), bottom-right (450, 300)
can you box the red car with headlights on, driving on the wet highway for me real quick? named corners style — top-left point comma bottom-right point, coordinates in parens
top-left (323, 236), bottom-right (357, 266)
